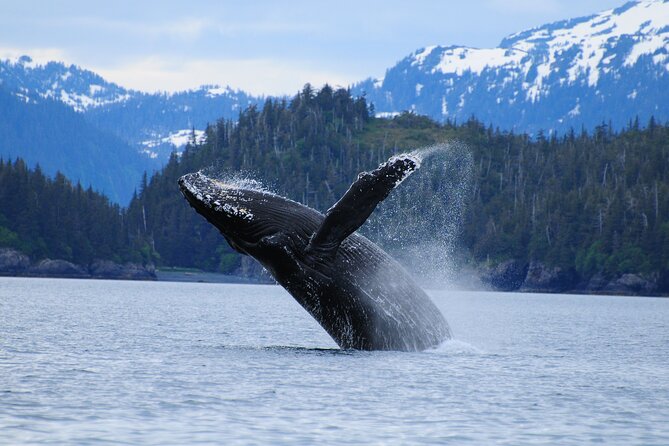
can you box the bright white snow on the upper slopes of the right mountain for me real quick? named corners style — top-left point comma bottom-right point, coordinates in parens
top-left (418, 0), bottom-right (669, 96)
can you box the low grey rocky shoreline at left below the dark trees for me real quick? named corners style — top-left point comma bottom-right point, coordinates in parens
top-left (0, 248), bottom-right (157, 280)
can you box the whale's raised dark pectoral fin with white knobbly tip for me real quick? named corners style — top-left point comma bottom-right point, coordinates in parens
top-left (306, 154), bottom-right (420, 267)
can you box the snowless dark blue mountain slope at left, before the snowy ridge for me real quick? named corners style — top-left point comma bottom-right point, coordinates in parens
top-left (0, 88), bottom-right (149, 204)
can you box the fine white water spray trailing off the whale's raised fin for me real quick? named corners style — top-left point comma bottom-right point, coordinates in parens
top-left (364, 142), bottom-right (473, 286)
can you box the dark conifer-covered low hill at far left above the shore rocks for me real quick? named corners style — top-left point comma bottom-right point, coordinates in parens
top-left (0, 159), bottom-right (150, 265)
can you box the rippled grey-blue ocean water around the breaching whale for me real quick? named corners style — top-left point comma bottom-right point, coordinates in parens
top-left (0, 278), bottom-right (669, 445)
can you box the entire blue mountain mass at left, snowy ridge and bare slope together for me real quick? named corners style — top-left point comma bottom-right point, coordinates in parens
top-left (0, 56), bottom-right (262, 204)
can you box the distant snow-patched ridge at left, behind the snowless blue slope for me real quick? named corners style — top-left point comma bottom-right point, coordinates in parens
top-left (0, 56), bottom-right (262, 162)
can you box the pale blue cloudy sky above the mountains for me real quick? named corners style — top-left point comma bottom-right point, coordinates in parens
top-left (0, 0), bottom-right (625, 95)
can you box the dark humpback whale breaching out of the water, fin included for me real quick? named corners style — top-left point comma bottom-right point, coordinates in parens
top-left (179, 154), bottom-right (450, 351)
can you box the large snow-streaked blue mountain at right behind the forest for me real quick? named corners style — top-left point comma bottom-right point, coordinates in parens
top-left (353, 0), bottom-right (669, 134)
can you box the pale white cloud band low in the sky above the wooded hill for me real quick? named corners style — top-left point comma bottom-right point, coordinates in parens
top-left (96, 56), bottom-right (359, 95)
